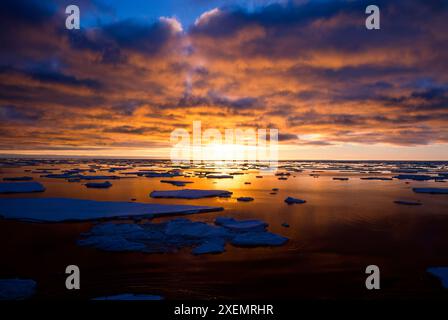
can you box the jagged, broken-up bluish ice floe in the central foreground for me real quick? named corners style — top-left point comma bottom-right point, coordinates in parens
top-left (78, 217), bottom-right (288, 255)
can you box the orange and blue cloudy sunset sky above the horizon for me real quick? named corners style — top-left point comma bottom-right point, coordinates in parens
top-left (0, 0), bottom-right (448, 160)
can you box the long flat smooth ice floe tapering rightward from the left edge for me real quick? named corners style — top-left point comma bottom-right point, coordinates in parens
top-left (0, 198), bottom-right (223, 222)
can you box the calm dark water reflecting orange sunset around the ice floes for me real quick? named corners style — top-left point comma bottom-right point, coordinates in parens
top-left (0, 160), bottom-right (448, 299)
